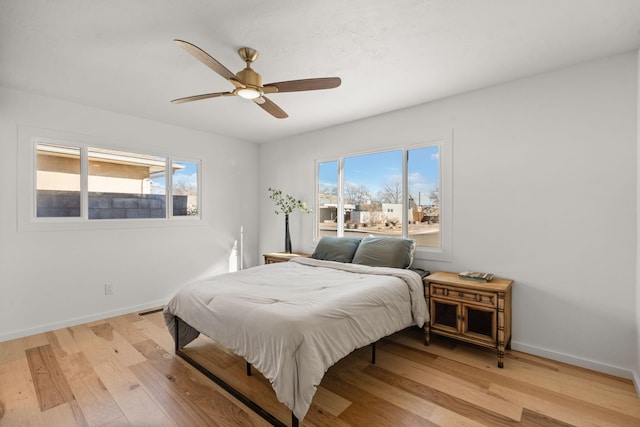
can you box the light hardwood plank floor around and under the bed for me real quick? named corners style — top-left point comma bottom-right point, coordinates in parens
top-left (0, 313), bottom-right (640, 427)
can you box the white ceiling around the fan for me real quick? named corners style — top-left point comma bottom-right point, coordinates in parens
top-left (0, 0), bottom-right (640, 142)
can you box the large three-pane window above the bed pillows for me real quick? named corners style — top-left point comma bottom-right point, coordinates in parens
top-left (316, 141), bottom-right (450, 259)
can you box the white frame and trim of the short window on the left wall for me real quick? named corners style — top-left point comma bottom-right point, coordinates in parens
top-left (16, 125), bottom-right (206, 231)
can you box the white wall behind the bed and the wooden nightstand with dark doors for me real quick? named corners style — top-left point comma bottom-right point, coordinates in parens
top-left (258, 52), bottom-right (638, 377)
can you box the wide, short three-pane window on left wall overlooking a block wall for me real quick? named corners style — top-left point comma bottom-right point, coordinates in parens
top-left (35, 138), bottom-right (199, 221)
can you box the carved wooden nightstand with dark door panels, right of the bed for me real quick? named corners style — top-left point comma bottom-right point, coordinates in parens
top-left (424, 271), bottom-right (513, 368)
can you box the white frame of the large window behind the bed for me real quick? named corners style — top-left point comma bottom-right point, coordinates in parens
top-left (313, 137), bottom-right (453, 261)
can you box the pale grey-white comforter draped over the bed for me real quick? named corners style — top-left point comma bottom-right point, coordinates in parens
top-left (164, 258), bottom-right (428, 421)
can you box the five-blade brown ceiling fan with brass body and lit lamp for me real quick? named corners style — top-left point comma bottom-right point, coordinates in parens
top-left (171, 39), bottom-right (342, 119)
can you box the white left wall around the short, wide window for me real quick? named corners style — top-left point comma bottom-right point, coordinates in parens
top-left (0, 88), bottom-right (258, 341)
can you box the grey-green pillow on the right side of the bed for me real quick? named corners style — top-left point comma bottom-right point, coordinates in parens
top-left (351, 237), bottom-right (416, 268)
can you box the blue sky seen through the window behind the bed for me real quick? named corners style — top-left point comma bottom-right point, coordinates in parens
top-left (319, 145), bottom-right (440, 204)
